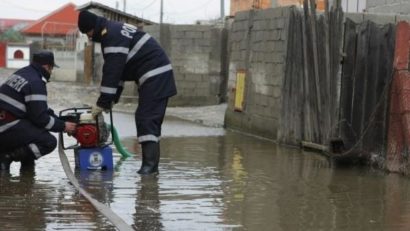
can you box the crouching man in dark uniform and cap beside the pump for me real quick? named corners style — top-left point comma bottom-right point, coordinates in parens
top-left (0, 51), bottom-right (76, 171)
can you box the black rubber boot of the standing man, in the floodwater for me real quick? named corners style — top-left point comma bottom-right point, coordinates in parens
top-left (138, 141), bottom-right (159, 175)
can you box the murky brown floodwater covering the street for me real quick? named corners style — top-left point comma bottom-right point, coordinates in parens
top-left (0, 114), bottom-right (410, 231)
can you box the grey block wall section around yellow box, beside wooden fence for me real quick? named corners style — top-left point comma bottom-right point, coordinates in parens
top-left (225, 7), bottom-right (291, 139)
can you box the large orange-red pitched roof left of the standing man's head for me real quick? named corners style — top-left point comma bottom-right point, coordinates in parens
top-left (21, 3), bottom-right (79, 36)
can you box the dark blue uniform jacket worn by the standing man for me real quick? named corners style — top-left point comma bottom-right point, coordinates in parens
top-left (93, 18), bottom-right (177, 108)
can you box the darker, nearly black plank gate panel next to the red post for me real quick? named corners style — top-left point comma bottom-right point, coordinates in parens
top-left (339, 19), bottom-right (395, 160)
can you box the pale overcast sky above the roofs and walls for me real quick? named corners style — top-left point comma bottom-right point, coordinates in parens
top-left (0, 0), bottom-right (230, 24)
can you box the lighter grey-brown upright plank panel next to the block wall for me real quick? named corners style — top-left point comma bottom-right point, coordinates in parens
top-left (278, 0), bottom-right (343, 146)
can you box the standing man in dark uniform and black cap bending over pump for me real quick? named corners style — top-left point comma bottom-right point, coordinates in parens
top-left (78, 11), bottom-right (177, 175)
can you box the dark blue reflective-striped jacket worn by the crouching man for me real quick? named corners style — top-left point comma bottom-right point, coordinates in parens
top-left (0, 63), bottom-right (65, 132)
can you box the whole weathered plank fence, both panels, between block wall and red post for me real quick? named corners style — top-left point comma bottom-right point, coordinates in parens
top-left (278, 0), bottom-right (400, 168)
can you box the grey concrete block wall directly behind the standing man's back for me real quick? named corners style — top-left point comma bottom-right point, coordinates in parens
top-left (144, 25), bottom-right (226, 106)
